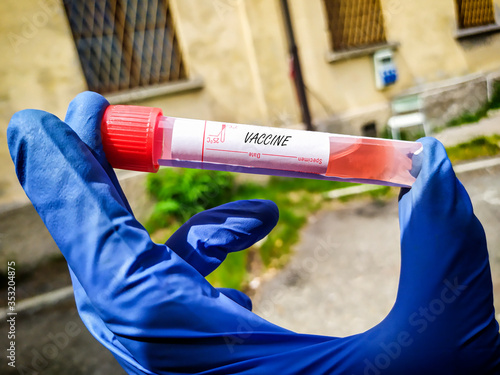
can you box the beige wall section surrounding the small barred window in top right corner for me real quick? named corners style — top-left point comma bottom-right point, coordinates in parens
top-left (383, 0), bottom-right (500, 84)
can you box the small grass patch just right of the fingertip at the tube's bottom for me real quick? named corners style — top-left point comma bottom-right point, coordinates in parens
top-left (446, 134), bottom-right (500, 163)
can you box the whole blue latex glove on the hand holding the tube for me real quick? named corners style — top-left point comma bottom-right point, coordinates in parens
top-left (8, 93), bottom-right (500, 375)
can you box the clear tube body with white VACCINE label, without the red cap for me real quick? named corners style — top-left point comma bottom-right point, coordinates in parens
top-left (154, 116), bottom-right (422, 187)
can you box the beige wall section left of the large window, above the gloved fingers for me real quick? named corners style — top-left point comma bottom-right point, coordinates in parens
top-left (0, 0), bottom-right (85, 205)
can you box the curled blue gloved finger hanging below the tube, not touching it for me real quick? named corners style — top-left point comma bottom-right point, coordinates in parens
top-left (166, 199), bottom-right (279, 276)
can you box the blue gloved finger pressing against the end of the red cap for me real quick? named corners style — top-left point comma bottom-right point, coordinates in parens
top-left (65, 91), bottom-right (132, 212)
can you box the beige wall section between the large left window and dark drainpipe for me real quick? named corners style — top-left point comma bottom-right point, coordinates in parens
top-left (131, 0), bottom-right (297, 125)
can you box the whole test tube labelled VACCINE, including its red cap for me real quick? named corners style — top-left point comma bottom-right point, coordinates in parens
top-left (101, 105), bottom-right (422, 187)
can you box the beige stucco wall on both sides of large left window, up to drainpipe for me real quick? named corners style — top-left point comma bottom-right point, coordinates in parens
top-left (0, 0), bottom-right (298, 209)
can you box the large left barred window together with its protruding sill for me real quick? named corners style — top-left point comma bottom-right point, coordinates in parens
top-left (64, 0), bottom-right (203, 102)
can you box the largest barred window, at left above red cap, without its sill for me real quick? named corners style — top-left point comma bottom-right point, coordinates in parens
top-left (63, 0), bottom-right (186, 94)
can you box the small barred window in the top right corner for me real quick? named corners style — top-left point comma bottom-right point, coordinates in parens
top-left (456, 0), bottom-right (495, 29)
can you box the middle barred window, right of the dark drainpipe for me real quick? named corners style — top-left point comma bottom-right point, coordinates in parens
top-left (324, 0), bottom-right (386, 52)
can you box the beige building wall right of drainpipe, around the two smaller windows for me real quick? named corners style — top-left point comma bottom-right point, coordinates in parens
top-left (290, 0), bottom-right (500, 134)
